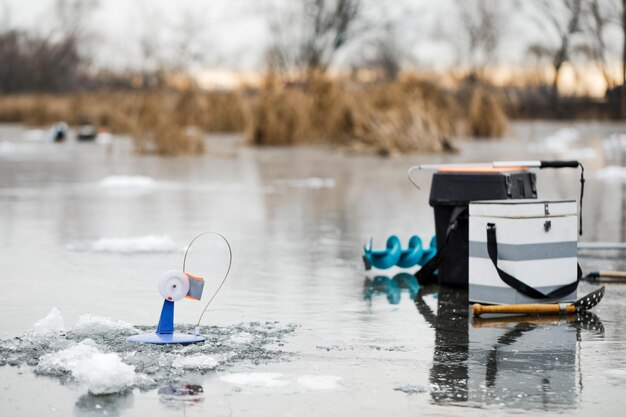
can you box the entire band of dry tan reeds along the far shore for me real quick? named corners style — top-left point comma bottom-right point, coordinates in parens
top-left (0, 73), bottom-right (507, 155)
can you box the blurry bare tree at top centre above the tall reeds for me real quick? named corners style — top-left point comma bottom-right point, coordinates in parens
top-left (268, 0), bottom-right (361, 73)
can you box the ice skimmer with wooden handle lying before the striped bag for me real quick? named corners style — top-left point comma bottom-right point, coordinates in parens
top-left (472, 286), bottom-right (604, 316)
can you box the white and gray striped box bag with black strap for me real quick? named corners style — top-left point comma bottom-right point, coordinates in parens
top-left (469, 200), bottom-right (579, 304)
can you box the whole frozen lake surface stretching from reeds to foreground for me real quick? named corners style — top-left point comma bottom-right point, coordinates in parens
top-left (0, 122), bottom-right (626, 416)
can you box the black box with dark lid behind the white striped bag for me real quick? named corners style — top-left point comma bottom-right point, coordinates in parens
top-left (418, 169), bottom-right (537, 288)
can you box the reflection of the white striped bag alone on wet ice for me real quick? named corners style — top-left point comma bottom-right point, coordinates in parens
top-left (468, 317), bottom-right (577, 409)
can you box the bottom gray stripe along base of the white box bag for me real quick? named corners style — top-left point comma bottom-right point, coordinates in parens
top-left (469, 284), bottom-right (576, 304)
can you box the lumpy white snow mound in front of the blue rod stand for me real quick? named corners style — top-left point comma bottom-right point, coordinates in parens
top-left (35, 339), bottom-right (135, 395)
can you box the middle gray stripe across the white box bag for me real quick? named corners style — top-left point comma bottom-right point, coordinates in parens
top-left (469, 241), bottom-right (578, 261)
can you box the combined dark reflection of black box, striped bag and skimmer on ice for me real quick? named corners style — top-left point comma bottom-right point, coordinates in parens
top-left (416, 286), bottom-right (604, 410)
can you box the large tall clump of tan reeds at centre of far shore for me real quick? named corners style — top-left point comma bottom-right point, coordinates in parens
top-left (248, 74), bottom-right (458, 154)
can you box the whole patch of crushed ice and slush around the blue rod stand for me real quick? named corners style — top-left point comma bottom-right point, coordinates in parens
top-left (0, 308), bottom-right (295, 394)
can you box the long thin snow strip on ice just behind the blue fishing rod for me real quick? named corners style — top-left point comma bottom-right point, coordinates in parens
top-left (66, 235), bottom-right (180, 255)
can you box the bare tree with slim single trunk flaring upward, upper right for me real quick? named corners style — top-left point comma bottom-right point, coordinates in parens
top-left (528, 0), bottom-right (584, 107)
